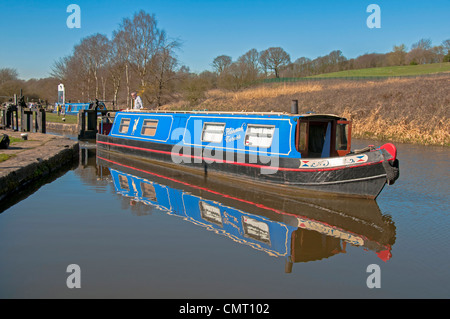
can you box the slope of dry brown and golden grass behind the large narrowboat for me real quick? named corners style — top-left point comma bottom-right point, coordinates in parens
top-left (162, 73), bottom-right (450, 146)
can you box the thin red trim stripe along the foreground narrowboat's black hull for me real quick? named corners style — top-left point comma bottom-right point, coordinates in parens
top-left (97, 141), bottom-right (383, 172)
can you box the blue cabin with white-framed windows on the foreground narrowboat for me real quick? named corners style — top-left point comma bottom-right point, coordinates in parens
top-left (105, 111), bottom-right (351, 158)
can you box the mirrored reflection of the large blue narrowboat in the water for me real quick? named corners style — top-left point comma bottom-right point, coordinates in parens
top-left (97, 150), bottom-right (395, 272)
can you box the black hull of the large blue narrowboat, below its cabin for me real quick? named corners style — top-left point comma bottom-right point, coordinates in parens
top-left (97, 135), bottom-right (386, 199)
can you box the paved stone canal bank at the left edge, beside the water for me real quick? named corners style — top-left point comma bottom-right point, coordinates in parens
top-left (0, 130), bottom-right (79, 201)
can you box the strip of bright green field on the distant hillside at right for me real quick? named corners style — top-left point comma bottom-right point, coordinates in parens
top-left (309, 62), bottom-right (450, 78)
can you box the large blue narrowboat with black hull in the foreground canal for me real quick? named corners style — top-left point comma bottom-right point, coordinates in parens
top-left (97, 110), bottom-right (399, 199)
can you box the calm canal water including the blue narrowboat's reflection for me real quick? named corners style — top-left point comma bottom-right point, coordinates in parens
top-left (0, 140), bottom-right (450, 299)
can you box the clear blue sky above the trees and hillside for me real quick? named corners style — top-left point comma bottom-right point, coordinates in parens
top-left (0, 0), bottom-right (450, 79)
